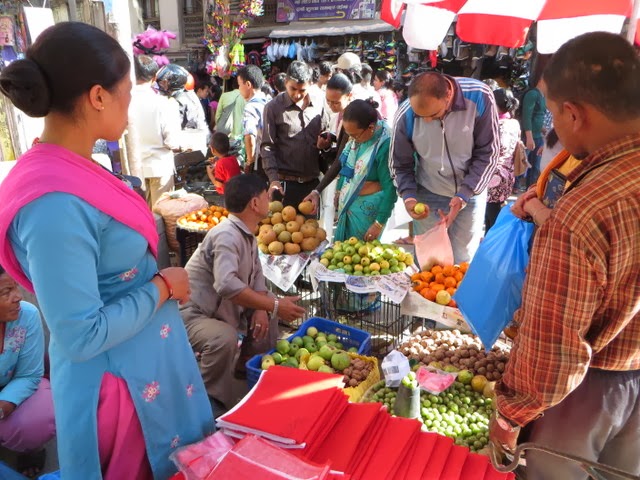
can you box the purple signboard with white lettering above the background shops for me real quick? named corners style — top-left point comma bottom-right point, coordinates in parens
top-left (276, 0), bottom-right (376, 22)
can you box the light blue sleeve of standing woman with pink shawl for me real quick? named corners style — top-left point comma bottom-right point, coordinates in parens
top-left (13, 193), bottom-right (159, 362)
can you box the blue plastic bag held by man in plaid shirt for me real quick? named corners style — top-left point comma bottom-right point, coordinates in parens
top-left (453, 205), bottom-right (533, 350)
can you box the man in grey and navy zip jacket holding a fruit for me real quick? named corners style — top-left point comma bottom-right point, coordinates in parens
top-left (389, 72), bottom-right (500, 263)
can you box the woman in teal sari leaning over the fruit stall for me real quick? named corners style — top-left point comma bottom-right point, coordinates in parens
top-left (305, 99), bottom-right (397, 241)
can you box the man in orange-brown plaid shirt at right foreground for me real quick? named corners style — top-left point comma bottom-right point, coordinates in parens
top-left (490, 32), bottom-right (640, 480)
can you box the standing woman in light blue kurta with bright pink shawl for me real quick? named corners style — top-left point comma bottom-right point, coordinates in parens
top-left (0, 23), bottom-right (213, 480)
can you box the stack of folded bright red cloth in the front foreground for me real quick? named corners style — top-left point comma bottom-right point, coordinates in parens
top-left (211, 366), bottom-right (515, 480)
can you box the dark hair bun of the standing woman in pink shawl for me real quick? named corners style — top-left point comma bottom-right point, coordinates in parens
top-left (0, 58), bottom-right (51, 117)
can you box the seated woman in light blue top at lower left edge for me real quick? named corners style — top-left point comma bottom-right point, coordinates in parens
top-left (0, 266), bottom-right (56, 474)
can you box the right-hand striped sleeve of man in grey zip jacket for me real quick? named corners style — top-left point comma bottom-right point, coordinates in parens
top-left (457, 85), bottom-right (500, 201)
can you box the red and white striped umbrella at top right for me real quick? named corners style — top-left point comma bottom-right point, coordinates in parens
top-left (381, 0), bottom-right (640, 53)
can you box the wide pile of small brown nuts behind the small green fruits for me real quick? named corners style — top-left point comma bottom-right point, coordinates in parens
top-left (399, 329), bottom-right (509, 382)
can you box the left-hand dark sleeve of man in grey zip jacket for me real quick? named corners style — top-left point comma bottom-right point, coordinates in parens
top-left (389, 100), bottom-right (418, 200)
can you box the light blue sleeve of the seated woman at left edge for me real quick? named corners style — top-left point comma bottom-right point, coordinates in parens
top-left (0, 302), bottom-right (44, 406)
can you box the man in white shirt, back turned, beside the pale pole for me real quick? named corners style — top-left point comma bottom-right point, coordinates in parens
top-left (129, 55), bottom-right (181, 206)
